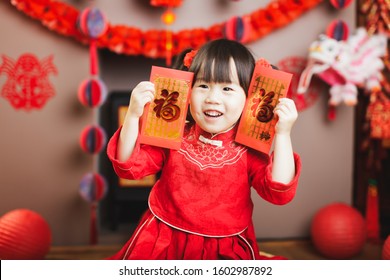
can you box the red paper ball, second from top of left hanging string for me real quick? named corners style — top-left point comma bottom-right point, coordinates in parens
top-left (78, 77), bottom-right (107, 108)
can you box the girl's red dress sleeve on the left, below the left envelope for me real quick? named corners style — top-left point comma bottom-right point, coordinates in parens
top-left (107, 127), bottom-right (166, 180)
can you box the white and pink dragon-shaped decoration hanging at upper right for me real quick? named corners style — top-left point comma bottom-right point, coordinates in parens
top-left (297, 27), bottom-right (387, 118)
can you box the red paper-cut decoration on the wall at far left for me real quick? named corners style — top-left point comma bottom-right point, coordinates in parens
top-left (0, 53), bottom-right (57, 111)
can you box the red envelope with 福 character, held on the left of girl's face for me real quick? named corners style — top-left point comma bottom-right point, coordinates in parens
top-left (139, 66), bottom-right (194, 150)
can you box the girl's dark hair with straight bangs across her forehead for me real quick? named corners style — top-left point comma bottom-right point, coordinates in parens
top-left (189, 39), bottom-right (255, 93)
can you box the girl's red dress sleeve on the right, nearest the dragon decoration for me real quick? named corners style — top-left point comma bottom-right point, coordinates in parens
top-left (248, 152), bottom-right (301, 205)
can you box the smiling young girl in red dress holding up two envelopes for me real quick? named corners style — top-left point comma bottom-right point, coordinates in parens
top-left (107, 39), bottom-right (300, 259)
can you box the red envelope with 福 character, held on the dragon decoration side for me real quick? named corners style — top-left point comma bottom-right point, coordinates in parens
top-left (235, 63), bottom-right (292, 154)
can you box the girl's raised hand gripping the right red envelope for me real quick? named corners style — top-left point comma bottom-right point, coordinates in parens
top-left (274, 98), bottom-right (298, 134)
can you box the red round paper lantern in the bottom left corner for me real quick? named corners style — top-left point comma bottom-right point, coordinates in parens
top-left (0, 209), bottom-right (51, 260)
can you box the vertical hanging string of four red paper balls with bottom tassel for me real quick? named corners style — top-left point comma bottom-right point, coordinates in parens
top-left (76, 3), bottom-right (108, 245)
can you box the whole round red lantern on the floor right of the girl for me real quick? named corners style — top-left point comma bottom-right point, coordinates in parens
top-left (311, 203), bottom-right (366, 259)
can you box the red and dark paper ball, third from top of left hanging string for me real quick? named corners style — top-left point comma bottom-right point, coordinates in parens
top-left (80, 125), bottom-right (107, 154)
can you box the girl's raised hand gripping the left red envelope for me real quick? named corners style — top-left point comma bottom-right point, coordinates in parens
top-left (127, 81), bottom-right (155, 118)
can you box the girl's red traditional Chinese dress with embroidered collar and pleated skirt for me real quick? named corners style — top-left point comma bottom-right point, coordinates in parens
top-left (107, 125), bottom-right (301, 259)
